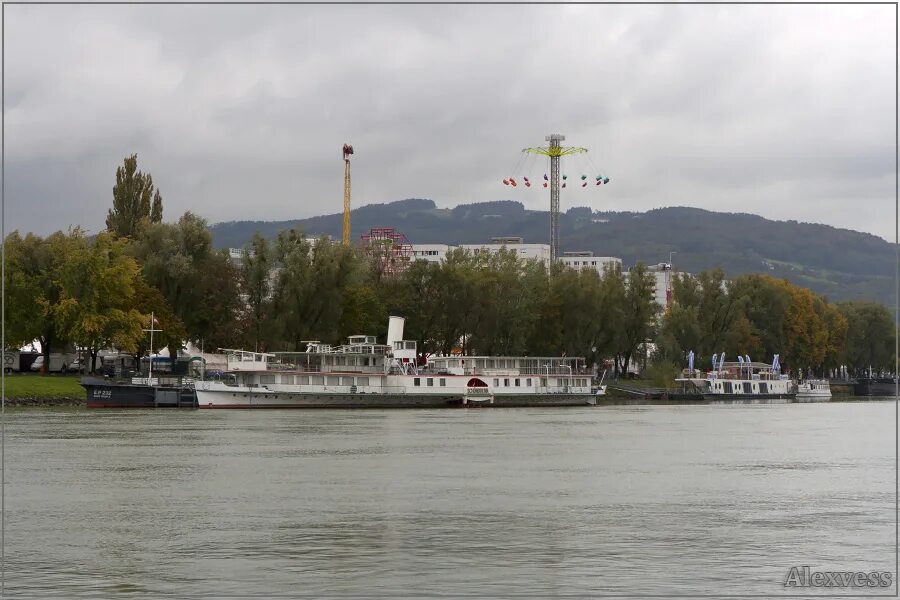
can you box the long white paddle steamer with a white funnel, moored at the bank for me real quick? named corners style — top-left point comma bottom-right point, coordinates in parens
top-left (195, 317), bottom-right (596, 408)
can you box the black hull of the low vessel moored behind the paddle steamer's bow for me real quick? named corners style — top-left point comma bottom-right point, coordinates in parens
top-left (80, 377), bottom-right (197, 408)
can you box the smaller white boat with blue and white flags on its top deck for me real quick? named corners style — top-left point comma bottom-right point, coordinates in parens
top-left (675, 352), bottom-right (797, 402)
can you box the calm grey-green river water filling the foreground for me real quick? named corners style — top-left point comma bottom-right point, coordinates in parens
top-left (5, 401), bottom-right (897, 598)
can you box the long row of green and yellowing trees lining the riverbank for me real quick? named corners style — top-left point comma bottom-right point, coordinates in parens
top-left (4, 155), bottom-right (897, 384)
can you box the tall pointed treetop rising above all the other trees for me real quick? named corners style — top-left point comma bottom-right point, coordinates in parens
top-left (106, 154), bottom-right (162, 239)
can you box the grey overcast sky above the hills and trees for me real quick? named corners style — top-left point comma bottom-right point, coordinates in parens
top-left (4, 5), bottom-right (895, 242)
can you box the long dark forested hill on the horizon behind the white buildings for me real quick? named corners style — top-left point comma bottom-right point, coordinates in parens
top-left (210, 199), bottom-right (896, 306)
